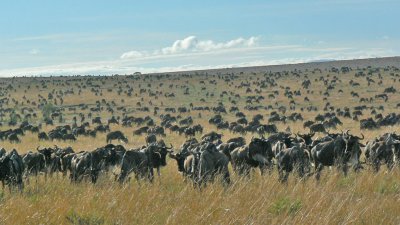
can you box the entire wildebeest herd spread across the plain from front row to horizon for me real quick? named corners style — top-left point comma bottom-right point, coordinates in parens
top-left (0, 59), bottom-right (400, 190)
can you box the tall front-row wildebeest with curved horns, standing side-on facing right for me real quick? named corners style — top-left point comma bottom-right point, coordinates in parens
top-left (311, 131), bottom-right (365, 180)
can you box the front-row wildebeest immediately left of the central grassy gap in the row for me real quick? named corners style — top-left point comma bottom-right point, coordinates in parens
top-left (118, 144), bottom-right (172, 183)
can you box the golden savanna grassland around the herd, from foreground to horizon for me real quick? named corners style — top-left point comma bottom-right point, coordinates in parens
top-left (0, 58), bottom-right (400, 224)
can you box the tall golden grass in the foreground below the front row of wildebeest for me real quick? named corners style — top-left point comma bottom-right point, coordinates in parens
top-left (0, 166), bottom-right (400, 224)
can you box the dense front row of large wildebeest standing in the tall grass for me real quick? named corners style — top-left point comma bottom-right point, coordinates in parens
top-left (0, 130), bottom-right (400, 190)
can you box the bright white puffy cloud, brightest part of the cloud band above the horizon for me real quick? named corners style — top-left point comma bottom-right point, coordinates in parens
top-left (120, 36), bottom-right (259, 59)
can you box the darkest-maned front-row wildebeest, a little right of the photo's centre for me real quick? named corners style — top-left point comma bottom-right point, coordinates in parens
top-left (231, 138), bottom-right (274, 175)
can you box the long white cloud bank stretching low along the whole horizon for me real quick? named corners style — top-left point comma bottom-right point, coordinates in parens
top-left (0, 36), bottom-right (396, 77)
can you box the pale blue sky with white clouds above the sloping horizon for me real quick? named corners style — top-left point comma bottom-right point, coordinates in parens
top-left (0, 0), bottom-right (400, 76)
